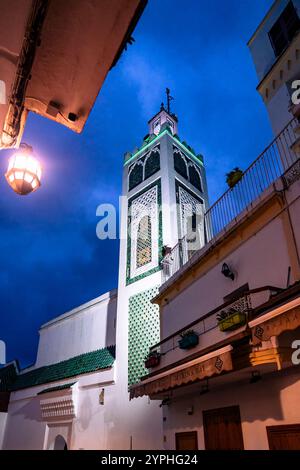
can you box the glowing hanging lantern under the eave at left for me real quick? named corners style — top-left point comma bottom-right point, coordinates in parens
top-left (5, 144), bottom-right (42, 196)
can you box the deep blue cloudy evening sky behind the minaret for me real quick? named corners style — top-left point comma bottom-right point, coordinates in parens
top-left (0, 0), bottom-right (273, 365)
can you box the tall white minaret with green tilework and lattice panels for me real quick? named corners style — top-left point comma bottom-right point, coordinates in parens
top-left (110, 89), bottom-right (207, 449)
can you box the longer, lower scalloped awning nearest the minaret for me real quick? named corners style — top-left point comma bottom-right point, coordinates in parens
top-left (130, 345), bottom-right (233, 398)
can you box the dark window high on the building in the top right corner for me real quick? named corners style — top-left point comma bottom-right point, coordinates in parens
top-left (269, 2), bottom-right (300, 57)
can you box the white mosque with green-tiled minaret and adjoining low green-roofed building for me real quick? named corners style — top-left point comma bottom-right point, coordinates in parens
top-left (0, 105), bottom-right (207, 449)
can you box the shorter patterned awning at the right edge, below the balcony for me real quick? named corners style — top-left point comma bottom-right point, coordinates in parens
top-left (249, 297), bottom-right (300, 345)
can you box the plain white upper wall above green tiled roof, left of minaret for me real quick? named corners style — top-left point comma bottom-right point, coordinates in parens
top-left (36, 291), bottom-right (117, 367)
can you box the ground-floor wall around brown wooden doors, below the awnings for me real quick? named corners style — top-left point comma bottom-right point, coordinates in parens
top-left (164, 369), bottom-right (300, 450)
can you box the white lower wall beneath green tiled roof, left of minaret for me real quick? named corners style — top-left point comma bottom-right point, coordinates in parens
top-left (0, 368), bottom-right (118, 450)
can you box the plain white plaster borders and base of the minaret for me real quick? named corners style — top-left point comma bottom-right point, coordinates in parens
top-left (109, 129), bottom-right (206, 449)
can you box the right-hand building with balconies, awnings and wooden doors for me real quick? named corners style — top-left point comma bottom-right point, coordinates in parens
top-left (131, 0), bottom-right (300, 450)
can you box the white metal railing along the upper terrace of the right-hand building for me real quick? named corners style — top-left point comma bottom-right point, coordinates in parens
top-left (162, 118), bottom-right (300, 282)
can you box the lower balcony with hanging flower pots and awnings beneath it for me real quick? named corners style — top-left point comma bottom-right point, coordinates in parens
top-left (130, 282), bottom-right (300, 400)
